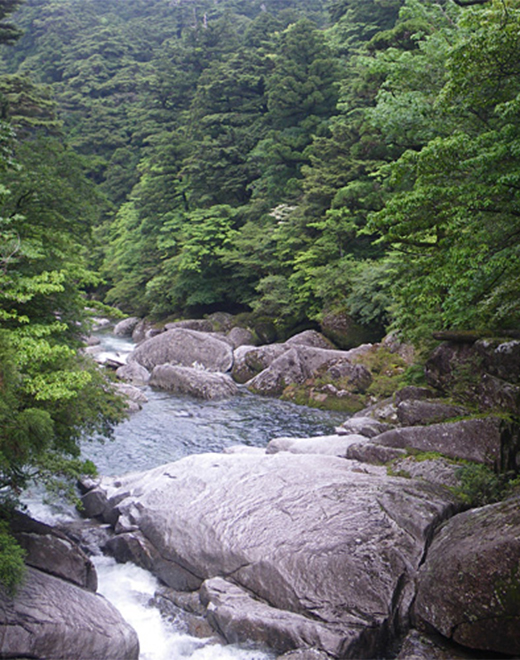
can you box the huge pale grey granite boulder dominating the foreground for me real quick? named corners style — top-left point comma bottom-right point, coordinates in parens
top-left (85, 452), bottom-right (456, 658)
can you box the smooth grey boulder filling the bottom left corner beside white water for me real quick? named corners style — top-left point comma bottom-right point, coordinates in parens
top-left (0, 567), bottom-right (139, 660)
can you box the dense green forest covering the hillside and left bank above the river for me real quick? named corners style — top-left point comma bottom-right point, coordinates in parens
top-left (0, 0), bottom-right (520, 588)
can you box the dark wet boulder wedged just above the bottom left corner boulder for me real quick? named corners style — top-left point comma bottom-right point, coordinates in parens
top-left (10, 512), bottom-right (97, 592)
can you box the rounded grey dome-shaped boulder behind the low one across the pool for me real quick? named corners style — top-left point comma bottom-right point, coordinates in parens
top-left (128, 328), bottom-right (233, 371)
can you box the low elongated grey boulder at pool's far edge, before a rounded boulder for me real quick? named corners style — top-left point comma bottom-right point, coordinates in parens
top-left (150, 364), bottom-right (238, 400)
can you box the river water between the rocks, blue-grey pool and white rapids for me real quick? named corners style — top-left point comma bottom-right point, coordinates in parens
top-left (28, 333), bottom-right (345, 660)
